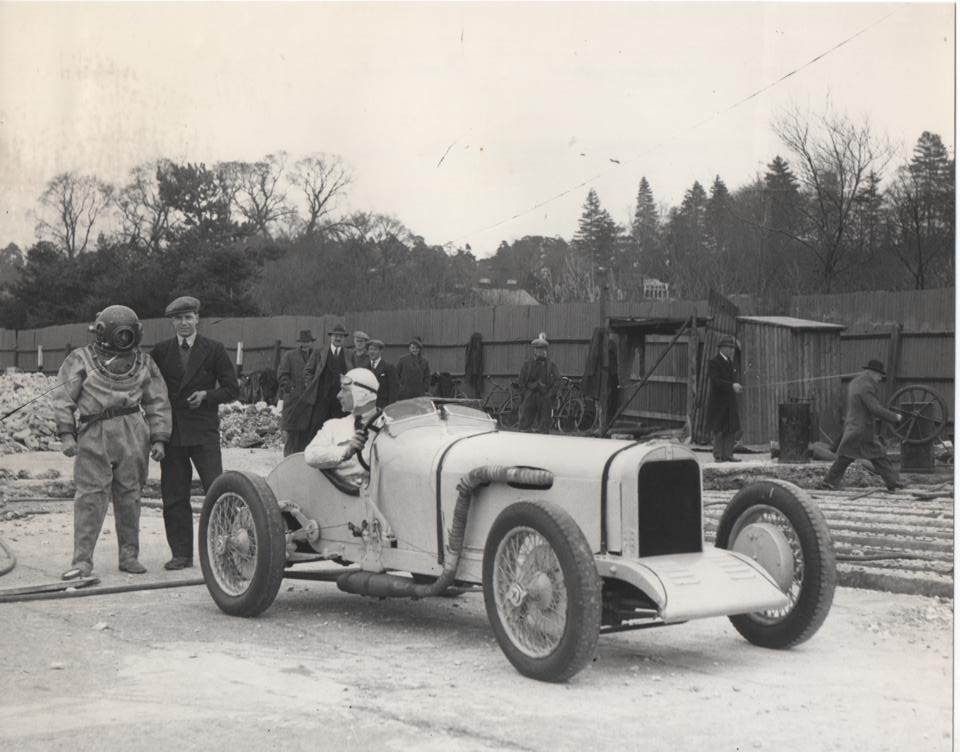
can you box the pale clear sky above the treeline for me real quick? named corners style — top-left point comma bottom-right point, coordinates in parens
top-left (0, 2), bottom-right (956, 256)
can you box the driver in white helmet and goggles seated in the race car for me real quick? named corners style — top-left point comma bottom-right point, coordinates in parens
top-left (303, 368), bottom-right (380, 486)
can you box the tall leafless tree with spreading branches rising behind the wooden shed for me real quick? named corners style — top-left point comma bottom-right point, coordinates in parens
top-left (773, 107), bottom-right (892, 292)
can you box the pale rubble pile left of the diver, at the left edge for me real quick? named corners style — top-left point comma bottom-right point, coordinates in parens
top-left (0, 373), bottom-right (60, 454)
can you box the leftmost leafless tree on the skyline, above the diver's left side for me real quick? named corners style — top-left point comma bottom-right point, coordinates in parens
top-left (36, 172), bottom-right (113, 258)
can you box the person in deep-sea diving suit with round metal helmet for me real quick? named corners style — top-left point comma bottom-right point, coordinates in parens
top-left (53, 305), bottom-right (172, 580)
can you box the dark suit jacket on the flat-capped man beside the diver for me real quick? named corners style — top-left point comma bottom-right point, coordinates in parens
top-left (150, 334), bottom-right (240, 446)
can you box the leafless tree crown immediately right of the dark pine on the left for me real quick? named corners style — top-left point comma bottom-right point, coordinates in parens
top-left (216, 151), bottom-right (293, 238)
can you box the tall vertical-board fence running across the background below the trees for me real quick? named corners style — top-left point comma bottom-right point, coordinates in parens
top-left (0, 289), bottom-right (955, 439)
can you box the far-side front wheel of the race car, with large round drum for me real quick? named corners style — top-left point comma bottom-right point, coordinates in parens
top-left (716, 480), bottom-right (837, 648)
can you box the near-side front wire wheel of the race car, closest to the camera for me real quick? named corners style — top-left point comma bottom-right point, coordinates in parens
top-left (483, 501), bottom-right (601, 682)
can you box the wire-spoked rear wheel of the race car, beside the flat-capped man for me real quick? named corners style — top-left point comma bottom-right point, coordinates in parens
top-left (199, 471), bottom-right (286, 616)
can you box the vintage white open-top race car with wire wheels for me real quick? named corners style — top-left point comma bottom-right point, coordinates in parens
top-left (199, 398), bottom-right (836, 681)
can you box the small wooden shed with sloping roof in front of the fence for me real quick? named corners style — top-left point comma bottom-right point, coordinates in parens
top-left (737, 316), bottom-right (844, 445)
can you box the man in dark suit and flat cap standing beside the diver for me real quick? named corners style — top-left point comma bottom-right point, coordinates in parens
top-left (151, 296), bottom-right (240, 569)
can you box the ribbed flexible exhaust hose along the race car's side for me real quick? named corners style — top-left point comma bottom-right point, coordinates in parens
top-left (337, 465), bottom-right (553, 599)
